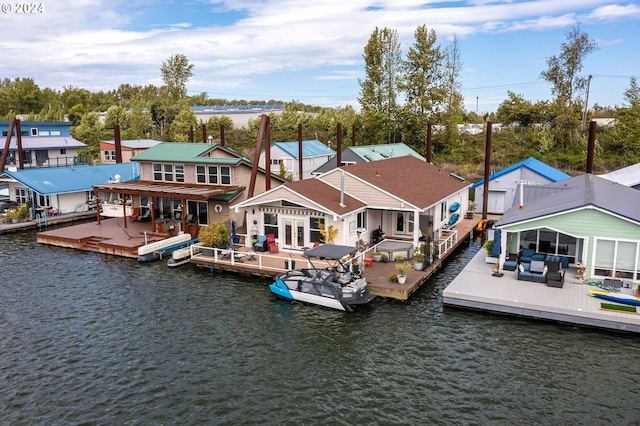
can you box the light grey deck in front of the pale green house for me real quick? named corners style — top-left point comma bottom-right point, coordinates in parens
top-left (443, 250), bottom-right (640, 333)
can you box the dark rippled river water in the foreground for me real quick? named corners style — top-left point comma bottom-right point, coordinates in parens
top-left (0, 233), bottom-right (640, 425)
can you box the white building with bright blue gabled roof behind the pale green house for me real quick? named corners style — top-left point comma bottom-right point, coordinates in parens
top-left (471, 157), bottom-right (571, 214)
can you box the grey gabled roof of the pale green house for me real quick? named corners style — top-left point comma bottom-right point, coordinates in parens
top-left (496, 174), bottom-right (640, 226)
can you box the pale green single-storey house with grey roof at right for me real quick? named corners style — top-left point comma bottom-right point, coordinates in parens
top-left (494, 174), bottom-right (640, 283)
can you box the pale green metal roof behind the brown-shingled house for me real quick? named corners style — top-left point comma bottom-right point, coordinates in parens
top-left (312, 143), bottom-right (426, 176)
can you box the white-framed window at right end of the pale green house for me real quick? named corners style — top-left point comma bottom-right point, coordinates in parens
top-left (593, 240), bottom-right (638, 279)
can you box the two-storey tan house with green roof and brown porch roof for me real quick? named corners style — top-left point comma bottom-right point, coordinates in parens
top-left (94, 142), bottom-right (285, 235)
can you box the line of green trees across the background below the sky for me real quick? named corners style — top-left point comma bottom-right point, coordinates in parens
top-left (0, 23), bottom-right (640, 179)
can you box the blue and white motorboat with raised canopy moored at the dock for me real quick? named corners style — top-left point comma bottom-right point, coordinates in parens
top-left (269, 244), bottom-right (375, 312)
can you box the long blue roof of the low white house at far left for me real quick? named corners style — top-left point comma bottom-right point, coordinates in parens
top-left (0, 163), bottom-right (140, 195)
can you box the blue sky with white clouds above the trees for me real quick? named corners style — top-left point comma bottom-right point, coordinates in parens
top-left (0, 0), bottom-right (640, 114)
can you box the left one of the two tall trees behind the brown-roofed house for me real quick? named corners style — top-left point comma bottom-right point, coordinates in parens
top-left (358, 27), bottom-right (402, 143)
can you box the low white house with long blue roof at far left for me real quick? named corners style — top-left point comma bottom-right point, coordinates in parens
top-left (0, 163), bottom-right (140, 214)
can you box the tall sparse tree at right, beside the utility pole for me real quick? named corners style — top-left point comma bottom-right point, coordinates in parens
top-left (540, 23), bottom-right (597, 143)
